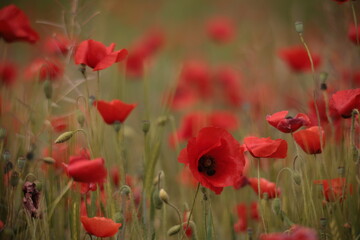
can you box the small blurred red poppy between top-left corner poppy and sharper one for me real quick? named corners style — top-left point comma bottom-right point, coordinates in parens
top-left (43, 34), bottom-right (72, 55)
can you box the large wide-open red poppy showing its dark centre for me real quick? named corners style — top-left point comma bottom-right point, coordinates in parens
top-left (178, 127), bottom-right (245, 194)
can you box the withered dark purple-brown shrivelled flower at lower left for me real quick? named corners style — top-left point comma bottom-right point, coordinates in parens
top-left (22, 182), bottom-right (40, 218)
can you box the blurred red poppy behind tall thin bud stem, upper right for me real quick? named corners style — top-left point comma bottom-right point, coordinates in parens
top-left (279, 46), bottom-right (321, 72)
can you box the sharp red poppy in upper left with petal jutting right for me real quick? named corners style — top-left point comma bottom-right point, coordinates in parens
top-left (75, 39), bottom-right (128, 71)
